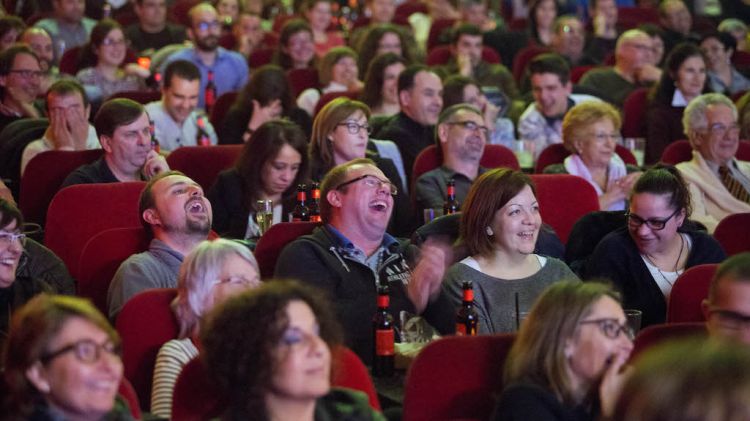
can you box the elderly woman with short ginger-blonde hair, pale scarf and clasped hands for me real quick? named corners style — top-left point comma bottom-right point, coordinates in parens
top-left (544, 101), bottom-right (640, 210)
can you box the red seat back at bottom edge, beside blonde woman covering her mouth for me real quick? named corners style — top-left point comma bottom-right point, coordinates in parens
top-left (403, 334), bottom-right (515, 421)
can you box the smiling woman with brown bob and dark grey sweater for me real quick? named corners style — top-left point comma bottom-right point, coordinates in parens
top-left (443, 168), bottom-right (578, 334)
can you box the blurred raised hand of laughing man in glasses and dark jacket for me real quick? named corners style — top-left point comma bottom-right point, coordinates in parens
top-left (406, 239), bottom-right (452, 314)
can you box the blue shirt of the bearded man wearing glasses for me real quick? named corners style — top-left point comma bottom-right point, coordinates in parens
top-left (159, 47), bottom-right (249, 108)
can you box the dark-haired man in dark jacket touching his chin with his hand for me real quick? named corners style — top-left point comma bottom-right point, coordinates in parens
top-left (62, 98), bottom-right (169, 187)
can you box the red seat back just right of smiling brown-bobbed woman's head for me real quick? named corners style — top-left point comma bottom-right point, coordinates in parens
top-left (531, 174), bottom-right (599, 244)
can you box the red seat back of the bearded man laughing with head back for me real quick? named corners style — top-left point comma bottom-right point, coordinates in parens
top-left (77, 227), bottom-right (150, 314)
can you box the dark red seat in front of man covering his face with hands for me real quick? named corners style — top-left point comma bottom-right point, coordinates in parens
top-left (18, 149), bottom-right (102, 225)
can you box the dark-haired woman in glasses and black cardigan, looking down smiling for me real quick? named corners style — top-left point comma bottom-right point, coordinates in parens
top-left (584, 165), bottom-right (725, 326)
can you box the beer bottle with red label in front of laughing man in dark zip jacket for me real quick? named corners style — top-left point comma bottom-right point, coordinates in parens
top-left (372, 285), bottom-right (396, 377)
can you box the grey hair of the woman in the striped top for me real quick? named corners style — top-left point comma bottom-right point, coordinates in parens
top-left (172, 238), bottom-right (260, 338)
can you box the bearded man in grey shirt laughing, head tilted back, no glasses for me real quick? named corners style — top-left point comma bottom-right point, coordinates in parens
top-left (107, 171), bottom-right (213, 320)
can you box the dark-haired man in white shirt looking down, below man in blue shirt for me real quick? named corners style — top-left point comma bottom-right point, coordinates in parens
top-left (146, 60), bottom-right (216, 152)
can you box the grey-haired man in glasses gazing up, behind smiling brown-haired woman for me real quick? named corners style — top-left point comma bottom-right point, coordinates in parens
top-left (415, 104), bottom-right (488, 217)
